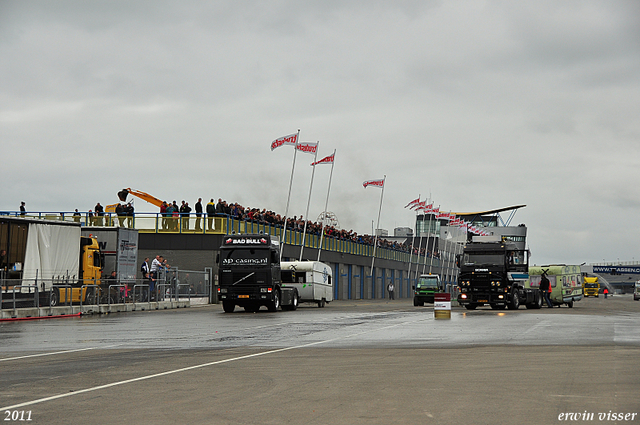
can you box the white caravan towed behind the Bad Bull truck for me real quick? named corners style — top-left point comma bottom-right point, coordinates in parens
top-left (280, 261), bottom-right (333, 307)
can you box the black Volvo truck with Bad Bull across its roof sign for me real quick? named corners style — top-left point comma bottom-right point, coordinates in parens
top-left (218, 234), bottom-right (300, 313)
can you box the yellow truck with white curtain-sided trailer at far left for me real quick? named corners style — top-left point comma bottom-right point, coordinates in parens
top-left (0, 217), bottom-right (102, 308)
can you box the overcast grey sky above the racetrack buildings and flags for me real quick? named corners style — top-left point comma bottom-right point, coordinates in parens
top-left (0, 0), bottom-right (640, 264)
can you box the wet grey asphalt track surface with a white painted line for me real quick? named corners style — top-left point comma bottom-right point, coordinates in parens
top-left (0, 295), bottom-right (640, 424)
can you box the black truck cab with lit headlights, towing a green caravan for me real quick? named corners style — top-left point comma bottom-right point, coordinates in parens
top-left (457, 236), bottom-right (542, 310)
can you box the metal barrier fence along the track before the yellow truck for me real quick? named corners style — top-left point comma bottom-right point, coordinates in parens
top-left (0, 268), bottom-right (211, 309)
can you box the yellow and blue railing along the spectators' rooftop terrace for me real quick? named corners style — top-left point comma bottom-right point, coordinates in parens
top-left (0, 212), bottom-right (441, 267)
